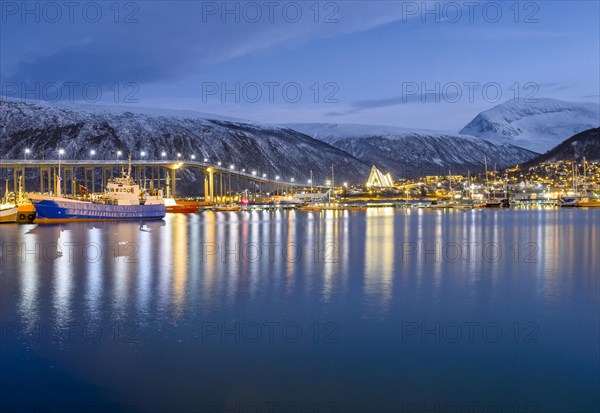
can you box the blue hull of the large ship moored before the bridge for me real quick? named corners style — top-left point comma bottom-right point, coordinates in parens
top-left (34, 199), bottom-right (166, 223)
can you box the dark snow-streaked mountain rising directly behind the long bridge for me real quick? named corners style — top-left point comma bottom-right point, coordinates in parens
top-left (0, 100), bottom-right (370, 192)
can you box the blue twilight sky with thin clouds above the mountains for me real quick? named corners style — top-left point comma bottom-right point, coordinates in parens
top-left (0, 0), bottom-right (600, 131)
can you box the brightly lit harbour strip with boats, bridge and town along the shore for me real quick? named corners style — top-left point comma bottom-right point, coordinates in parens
top-left (0, 155), bottom-right (600, 223)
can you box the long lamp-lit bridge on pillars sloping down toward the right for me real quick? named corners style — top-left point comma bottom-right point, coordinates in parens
top-left (0, 159), bottom-right (331, 203)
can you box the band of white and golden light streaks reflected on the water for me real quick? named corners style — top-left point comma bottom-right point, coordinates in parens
top-left (2, 208), bottom-right (600, 336)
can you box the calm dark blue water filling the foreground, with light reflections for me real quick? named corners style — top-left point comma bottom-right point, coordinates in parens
top-left (0, 209), bottom-right (600, 413)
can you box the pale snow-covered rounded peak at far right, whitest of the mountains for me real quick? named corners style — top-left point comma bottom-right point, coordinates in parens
top-left (460, 99), bottom-right (600, 153)
